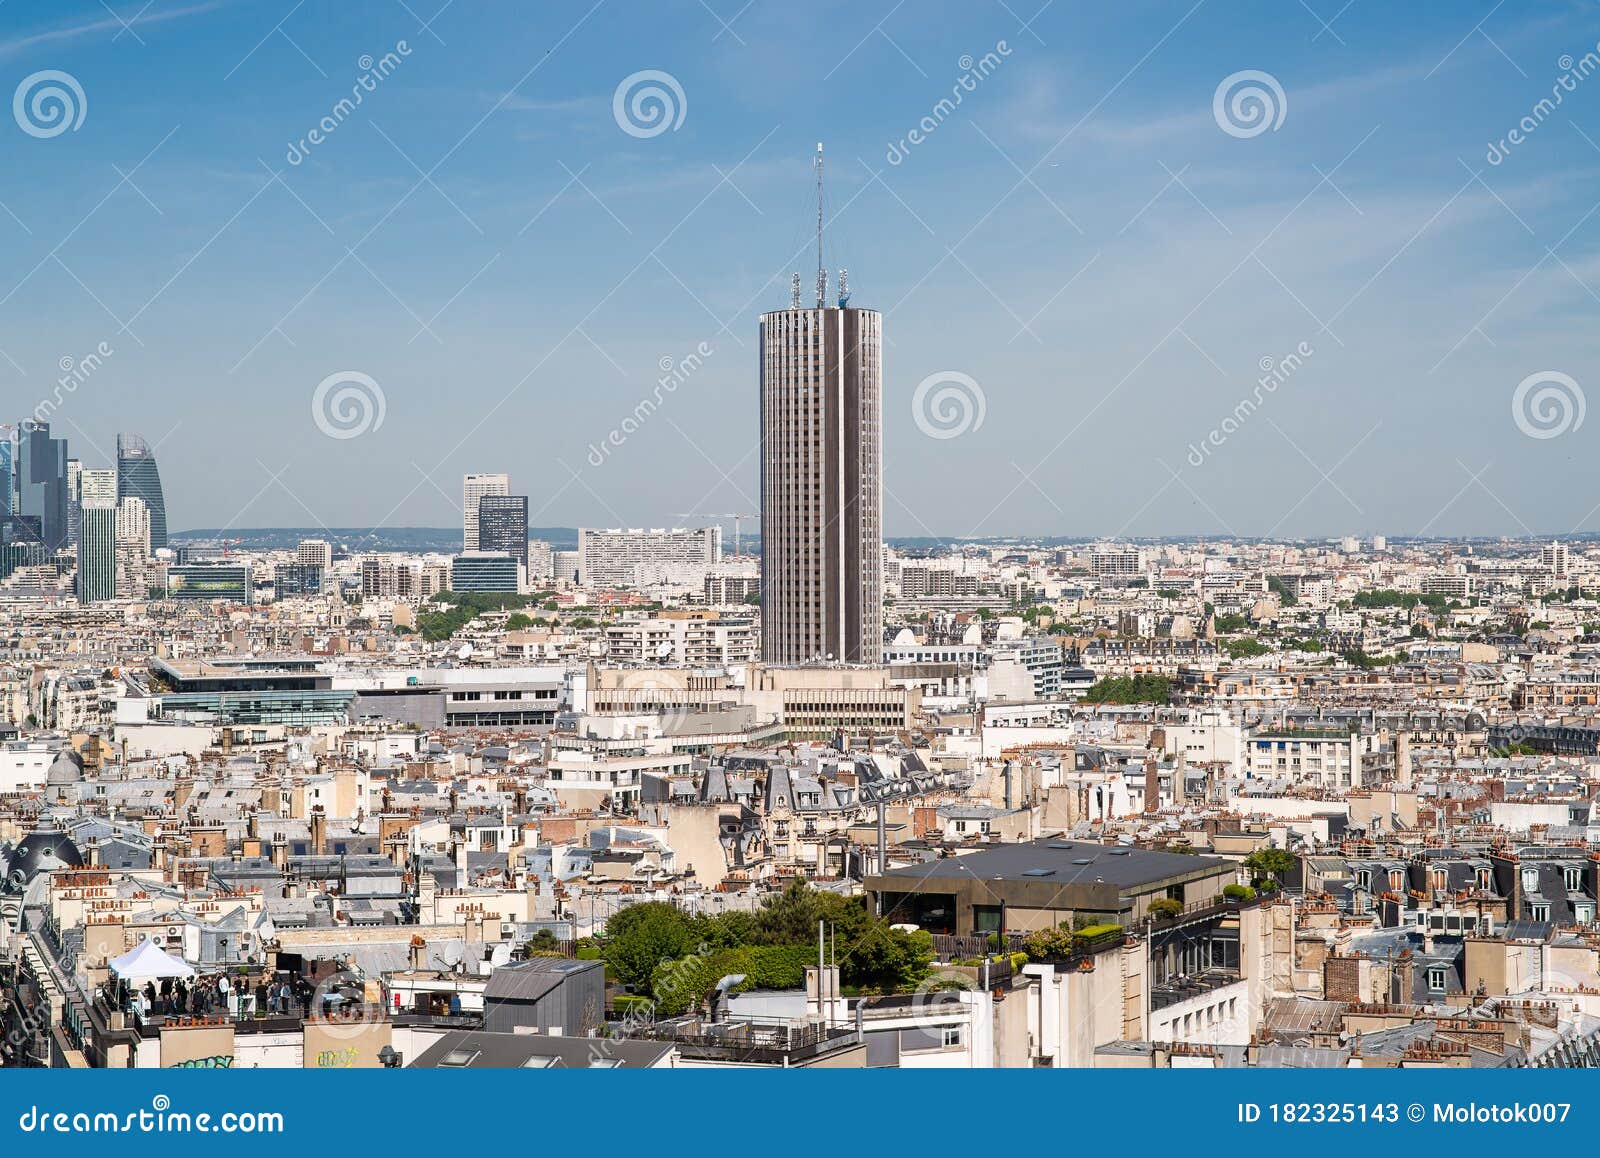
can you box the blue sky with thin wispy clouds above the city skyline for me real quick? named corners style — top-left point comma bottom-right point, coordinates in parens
top-left (0, 0), bottom-right (1600, 536)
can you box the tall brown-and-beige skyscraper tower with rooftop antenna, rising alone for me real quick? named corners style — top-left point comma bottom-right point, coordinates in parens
top-left (760, 299), bottom-right (883, 664)
